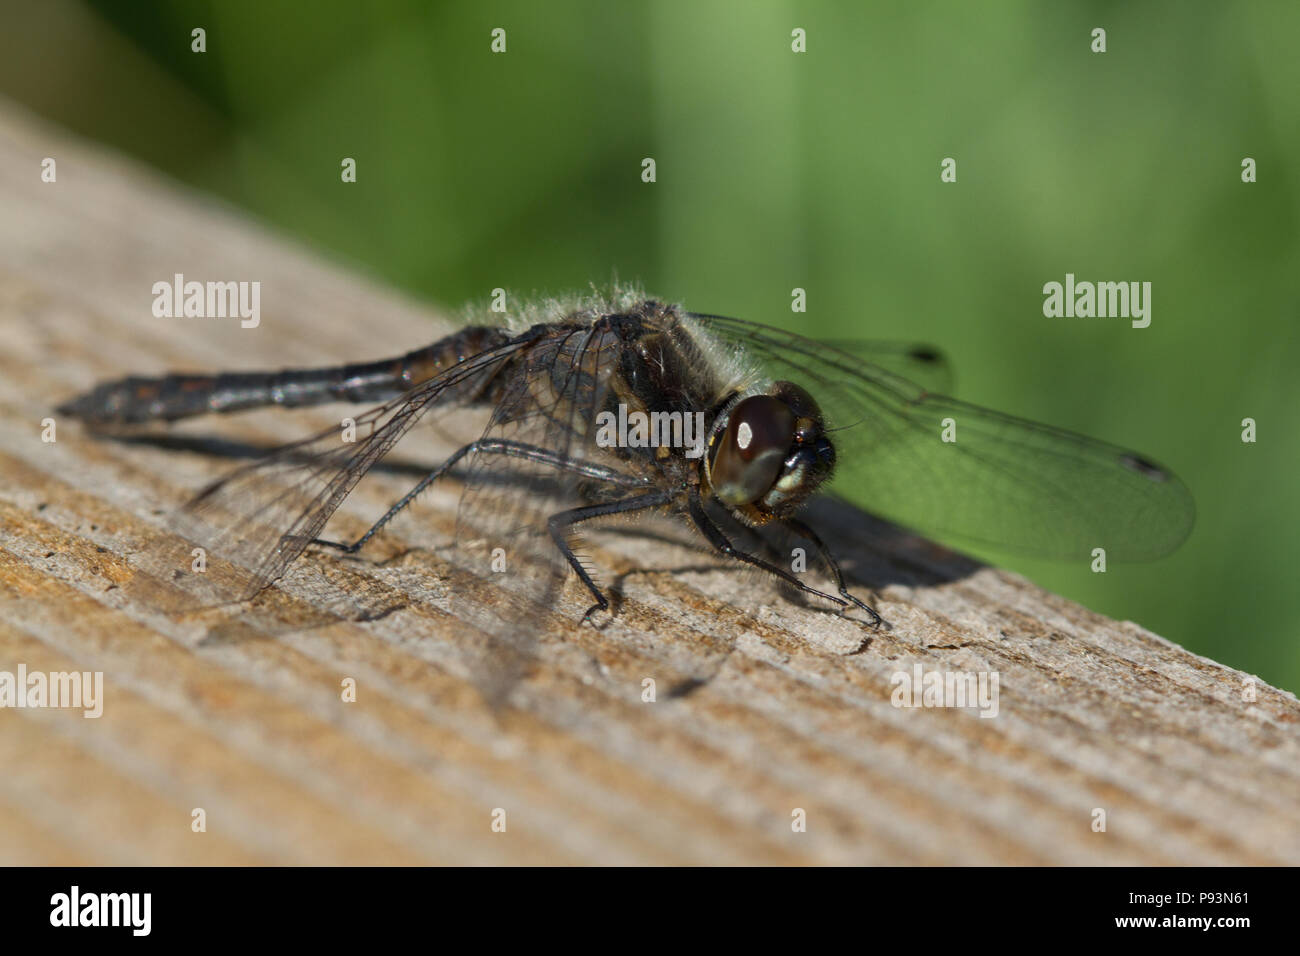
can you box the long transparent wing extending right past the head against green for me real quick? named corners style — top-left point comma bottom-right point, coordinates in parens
top-left (688, 316), bottom-right (1195, 559)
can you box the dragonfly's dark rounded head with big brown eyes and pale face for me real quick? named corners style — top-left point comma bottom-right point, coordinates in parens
top-left (705, 381), bottom-right (835, 524)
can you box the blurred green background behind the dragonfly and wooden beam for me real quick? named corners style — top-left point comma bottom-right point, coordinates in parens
top-left (0, 0), bottom-right (1300, 691)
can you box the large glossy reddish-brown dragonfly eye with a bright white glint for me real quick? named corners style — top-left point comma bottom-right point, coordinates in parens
top-left (710, 395), bottom-right (794, 505)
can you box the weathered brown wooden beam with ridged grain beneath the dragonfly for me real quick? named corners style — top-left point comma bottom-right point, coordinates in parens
top-left (0, 102), bottom-right (1300, 864)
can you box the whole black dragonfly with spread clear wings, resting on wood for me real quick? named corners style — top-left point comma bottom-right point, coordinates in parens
top-left (59, 289), bottom-right (1195, 626)
